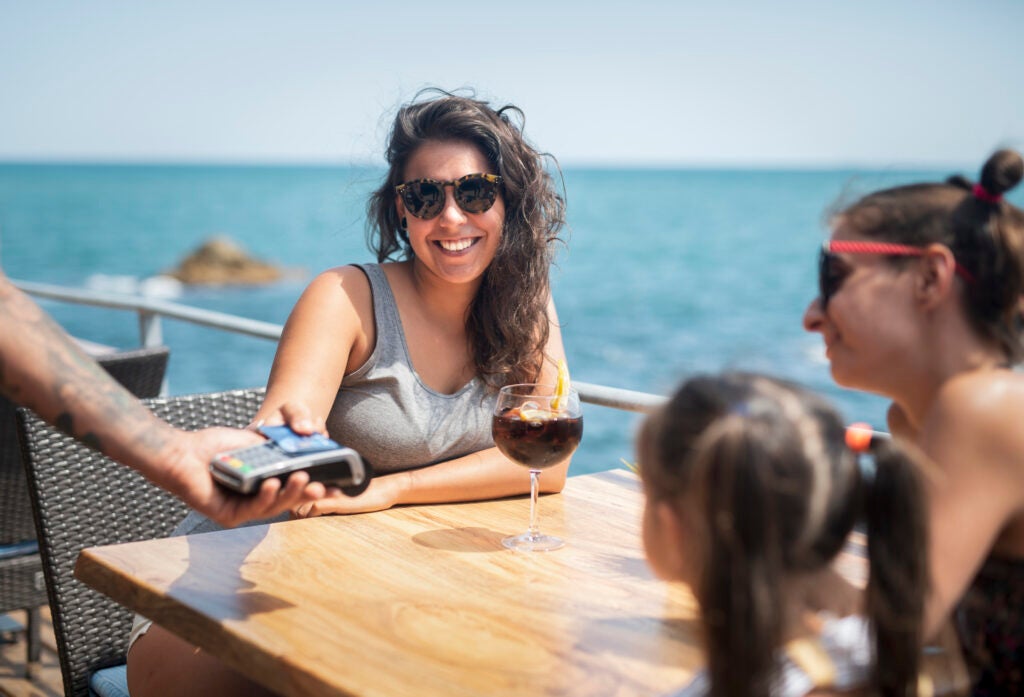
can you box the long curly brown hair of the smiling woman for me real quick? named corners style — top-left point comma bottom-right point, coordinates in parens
top-left (367, 89), bottom-right (565, 388)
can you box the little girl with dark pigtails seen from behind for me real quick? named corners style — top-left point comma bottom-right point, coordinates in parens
top-left (638, 374), bottom-right (928, 697)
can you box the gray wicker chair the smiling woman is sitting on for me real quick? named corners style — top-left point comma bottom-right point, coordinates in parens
top-left (17, 388), bottom-right (264, 697)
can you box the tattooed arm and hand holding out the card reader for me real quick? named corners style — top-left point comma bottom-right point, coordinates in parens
top-left (0, 271), bottom-right (325, 526)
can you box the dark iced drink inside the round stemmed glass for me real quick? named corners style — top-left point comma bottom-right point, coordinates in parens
top-left (492, 409), bottom-right (583, 470)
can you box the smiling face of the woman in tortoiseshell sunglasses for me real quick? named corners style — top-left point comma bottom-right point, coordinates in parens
top-left (395, 140), bottom-right (505, 290)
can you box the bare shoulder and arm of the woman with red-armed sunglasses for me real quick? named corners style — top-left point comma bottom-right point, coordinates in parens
top-left (920, 372), bottom-right (1024, 639)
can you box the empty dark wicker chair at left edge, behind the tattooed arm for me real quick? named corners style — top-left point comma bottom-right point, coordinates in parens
top-left (0, 346), bottom-right (169, 674)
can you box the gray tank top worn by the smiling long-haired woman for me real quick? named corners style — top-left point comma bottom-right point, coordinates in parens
top-left (327, 264), bottom-right (497, 474)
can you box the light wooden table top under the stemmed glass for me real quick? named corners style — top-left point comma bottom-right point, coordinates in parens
top-left (76, 471), bottom-right (702, 697)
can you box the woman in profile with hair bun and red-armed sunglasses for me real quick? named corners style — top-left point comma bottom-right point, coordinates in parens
top-left (804, 150), bottom-right (1024, 695)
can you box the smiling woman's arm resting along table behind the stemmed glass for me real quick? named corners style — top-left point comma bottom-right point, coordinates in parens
top-left (296, 290), bottom-right (569, 517)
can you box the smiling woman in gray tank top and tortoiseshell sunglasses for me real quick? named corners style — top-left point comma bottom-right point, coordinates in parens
top-left (128, 93), bottom-right (568, 695)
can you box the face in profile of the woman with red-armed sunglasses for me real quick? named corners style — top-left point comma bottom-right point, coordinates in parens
top-left (804, 223), bottom-right (923, 396)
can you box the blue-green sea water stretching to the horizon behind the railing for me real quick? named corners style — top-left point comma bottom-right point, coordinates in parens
top-left (0, 164), bottom-right (1007, 474)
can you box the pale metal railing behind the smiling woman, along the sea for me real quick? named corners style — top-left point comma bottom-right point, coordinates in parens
top-left (13, 280), bottom-right (666, 411)
